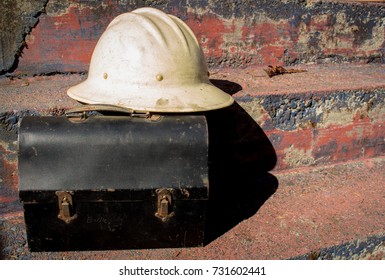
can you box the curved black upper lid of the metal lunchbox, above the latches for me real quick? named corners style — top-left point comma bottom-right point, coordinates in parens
top-left (18, 115), bottom-right (209, 202)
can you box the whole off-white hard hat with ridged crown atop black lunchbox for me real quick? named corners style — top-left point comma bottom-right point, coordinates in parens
top-left (67, 8), bottom-right (234, 112)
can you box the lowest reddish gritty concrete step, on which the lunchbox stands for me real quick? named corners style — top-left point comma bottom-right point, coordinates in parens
top-left (0, 158), bottom-right (385, 259)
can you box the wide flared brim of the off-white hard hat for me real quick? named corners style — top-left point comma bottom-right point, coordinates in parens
top-left (67, 79), bottom-right (234, 113)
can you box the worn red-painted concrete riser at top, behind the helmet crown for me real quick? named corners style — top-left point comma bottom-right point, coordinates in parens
top-left (6, 0), bottom-right (385, 74)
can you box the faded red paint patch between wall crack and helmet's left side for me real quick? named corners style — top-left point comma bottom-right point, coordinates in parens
top-left (19, 5), bottom-right (111, 73)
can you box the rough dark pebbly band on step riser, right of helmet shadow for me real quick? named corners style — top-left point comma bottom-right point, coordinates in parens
top-left (241, 89), bottom-right (385, 130)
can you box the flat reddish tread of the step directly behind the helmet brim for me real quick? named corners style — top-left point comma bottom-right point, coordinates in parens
top-left (0, 64), bottom-right (385, 110)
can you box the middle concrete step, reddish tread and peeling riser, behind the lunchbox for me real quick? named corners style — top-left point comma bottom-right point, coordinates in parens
top-left (0, 64), bottom-right (385, 170)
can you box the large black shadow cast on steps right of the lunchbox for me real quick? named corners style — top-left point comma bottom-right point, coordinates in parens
top-left (202, 93), bottom-right (278, 244)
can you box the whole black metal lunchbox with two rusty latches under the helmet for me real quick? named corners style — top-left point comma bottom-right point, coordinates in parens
top-left (18, 106), bottom-right (209, 251)
